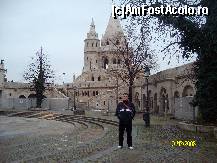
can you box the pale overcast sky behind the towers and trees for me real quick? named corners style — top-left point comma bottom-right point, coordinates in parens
top-left (0, 0), bottom-right (193, 83)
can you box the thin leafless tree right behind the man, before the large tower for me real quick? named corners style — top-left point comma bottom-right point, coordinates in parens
top-left (108, 24), bottom-right (156, 101)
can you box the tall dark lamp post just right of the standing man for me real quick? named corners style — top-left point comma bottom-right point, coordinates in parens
top-left (143, 66), bottom-right (150, 127)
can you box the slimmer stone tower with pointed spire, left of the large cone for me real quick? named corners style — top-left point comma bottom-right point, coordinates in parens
top-left (83, 19), bottom-right (100, 72)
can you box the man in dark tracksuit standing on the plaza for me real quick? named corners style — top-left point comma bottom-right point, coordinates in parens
top-left (115, 93), bottom-right (136, 149)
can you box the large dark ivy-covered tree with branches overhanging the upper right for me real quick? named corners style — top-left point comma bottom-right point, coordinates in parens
top-left (118, 0), bottom-right (217, 122)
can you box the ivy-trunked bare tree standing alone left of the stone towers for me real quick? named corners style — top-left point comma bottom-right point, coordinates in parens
top-left (23, 47), bottom-right (54, 108)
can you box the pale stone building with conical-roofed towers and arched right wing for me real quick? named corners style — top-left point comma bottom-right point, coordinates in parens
top-left (70, 17), bottom-right (195, 114)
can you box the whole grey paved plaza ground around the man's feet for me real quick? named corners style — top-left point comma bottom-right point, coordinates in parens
top-left (0, 111), bottom-right (217, 163)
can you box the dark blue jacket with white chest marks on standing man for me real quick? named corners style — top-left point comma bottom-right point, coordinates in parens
top-left (115, 102), bottom-right (136, 124)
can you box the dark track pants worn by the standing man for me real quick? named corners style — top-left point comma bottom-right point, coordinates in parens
top-left (119, 122), bottom-right (132, 147)
